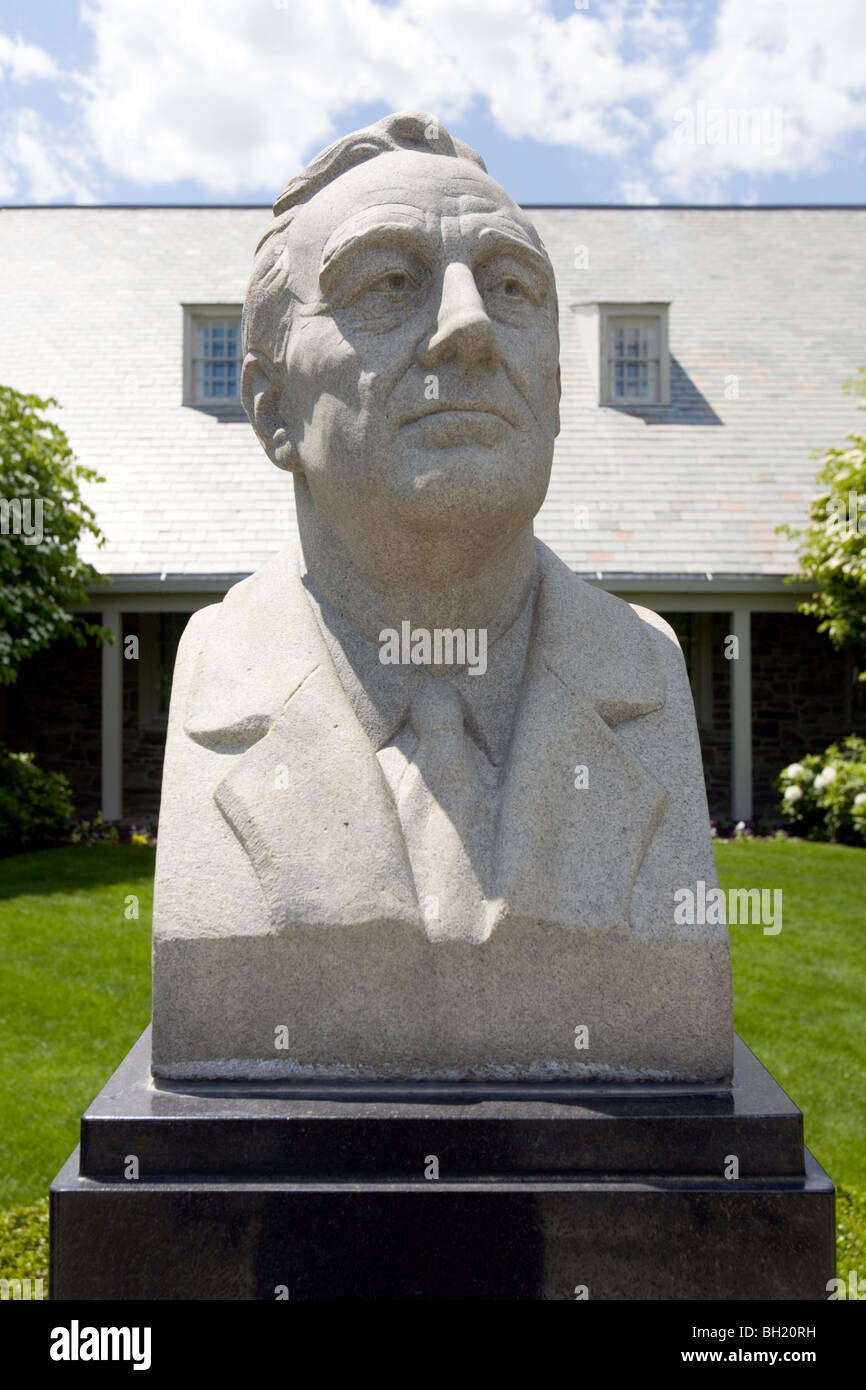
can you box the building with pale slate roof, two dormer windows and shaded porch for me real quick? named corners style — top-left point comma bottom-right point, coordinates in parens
top-left (0, 207), bottom-right (866, 819)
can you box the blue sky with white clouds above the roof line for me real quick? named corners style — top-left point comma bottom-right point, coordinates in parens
top-left (0, 0), bottom-right (866, 204)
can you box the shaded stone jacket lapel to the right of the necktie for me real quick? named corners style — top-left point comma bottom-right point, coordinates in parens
top-left (493, 545), bottom-right (666, 930)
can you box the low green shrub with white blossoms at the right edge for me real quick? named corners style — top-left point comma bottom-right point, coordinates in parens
top-left (776, 734), bottom-right (866, 845)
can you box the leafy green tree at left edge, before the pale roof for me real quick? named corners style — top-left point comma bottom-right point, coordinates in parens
top-left (0, 386), bottom-right (108, 685)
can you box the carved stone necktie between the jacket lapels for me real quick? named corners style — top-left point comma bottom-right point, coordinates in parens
top-left (396, 677), bottom-right (488, 941)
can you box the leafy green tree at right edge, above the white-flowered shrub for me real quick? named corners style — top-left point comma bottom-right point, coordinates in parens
top-left (778, 367), bottom-right (866, 680)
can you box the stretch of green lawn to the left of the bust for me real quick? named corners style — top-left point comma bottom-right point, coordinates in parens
top-left (0, 845), bottom-right (154, 1209)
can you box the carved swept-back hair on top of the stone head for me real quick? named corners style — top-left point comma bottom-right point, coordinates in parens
top-left (242, 111), bottom-right (487, 363)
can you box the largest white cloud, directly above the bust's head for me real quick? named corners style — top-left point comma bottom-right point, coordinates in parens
top-left (74, 0), bottom-right (685, 193)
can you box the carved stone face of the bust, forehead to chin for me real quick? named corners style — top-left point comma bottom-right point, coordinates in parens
top-left (273, 152), bottom-right (559, 541)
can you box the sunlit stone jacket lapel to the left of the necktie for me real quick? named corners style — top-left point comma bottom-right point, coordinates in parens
top-left (186, 556), bottom-right (420, 931)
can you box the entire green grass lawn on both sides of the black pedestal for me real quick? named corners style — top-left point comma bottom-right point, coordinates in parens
top-left (0, 841), bottom-right (866, 1277)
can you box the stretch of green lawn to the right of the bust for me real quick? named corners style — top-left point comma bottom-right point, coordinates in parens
top-left (716, 840), bottom-right (866, 1275)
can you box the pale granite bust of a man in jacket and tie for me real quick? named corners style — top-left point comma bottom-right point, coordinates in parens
top-left (153, 113), bottom-right (733, 1083)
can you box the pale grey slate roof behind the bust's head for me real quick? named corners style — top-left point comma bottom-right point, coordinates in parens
top-left (0, 207), bottom-right (866, 578)
